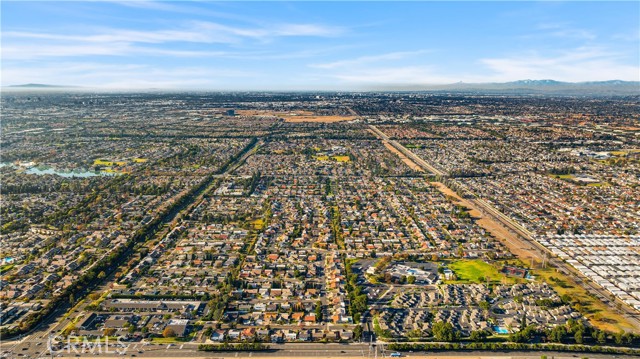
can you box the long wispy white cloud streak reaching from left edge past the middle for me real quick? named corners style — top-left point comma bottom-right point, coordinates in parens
top-left (2, 21), bottom-right (344, 59)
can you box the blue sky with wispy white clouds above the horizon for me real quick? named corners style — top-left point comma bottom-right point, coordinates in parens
top-left (1, 0), bottom-right (640, 90)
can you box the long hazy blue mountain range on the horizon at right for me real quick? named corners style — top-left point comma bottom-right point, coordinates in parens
top-left (372, 80), bottom-right (640, 95)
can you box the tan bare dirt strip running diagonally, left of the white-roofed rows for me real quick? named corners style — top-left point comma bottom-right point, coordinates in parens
top-left (433, 182), bottom-right (542, 263)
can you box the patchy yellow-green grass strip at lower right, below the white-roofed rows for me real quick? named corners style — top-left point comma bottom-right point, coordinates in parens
top-left (534, 268), bottom-right (640, 333)
